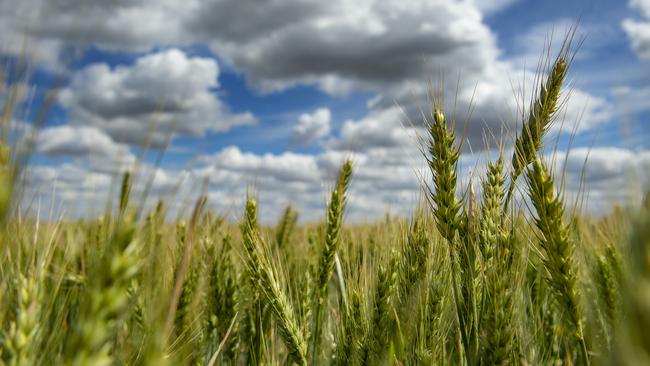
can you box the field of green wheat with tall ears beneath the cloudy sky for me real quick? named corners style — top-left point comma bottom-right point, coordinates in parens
top-left (0, 38), bottom-right (650, 365)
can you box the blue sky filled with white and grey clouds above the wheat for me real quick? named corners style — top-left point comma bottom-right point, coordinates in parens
top-left (0, 0), bottom-right (650, 222)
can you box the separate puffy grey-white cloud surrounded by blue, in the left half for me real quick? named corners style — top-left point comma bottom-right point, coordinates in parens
top-left (60, 49), bottom-right (255, 147)
